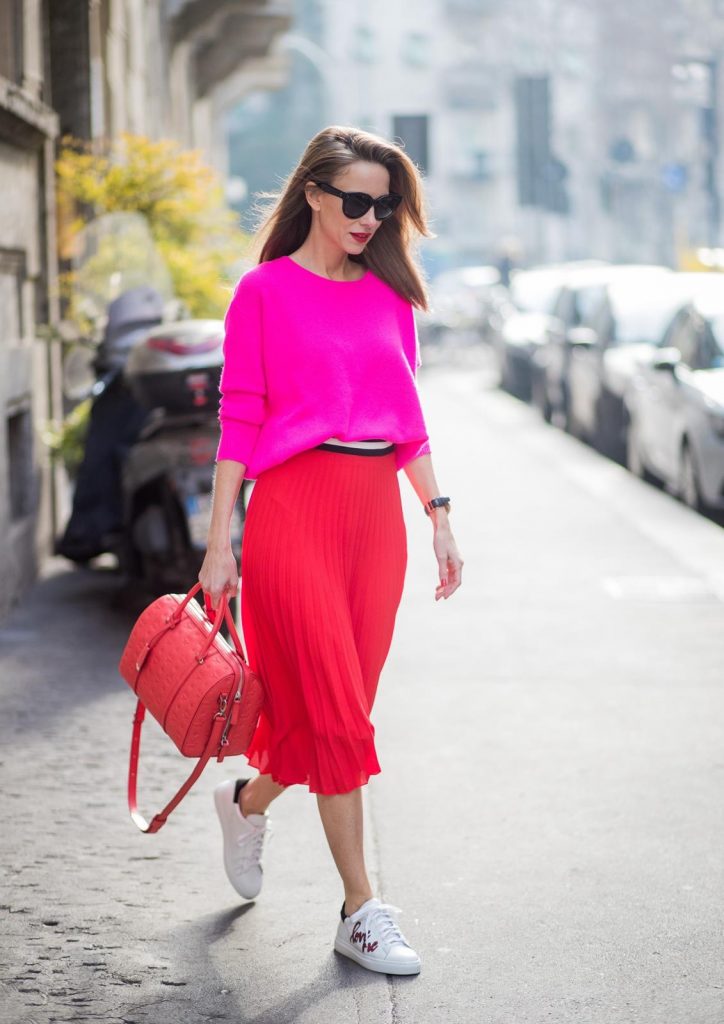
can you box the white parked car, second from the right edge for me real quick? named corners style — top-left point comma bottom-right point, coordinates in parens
top-left (567, 266), bottom-right (675, 462)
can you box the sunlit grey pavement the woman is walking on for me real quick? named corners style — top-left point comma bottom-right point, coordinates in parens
top-left (0, 360), bottom-right (724, 1024)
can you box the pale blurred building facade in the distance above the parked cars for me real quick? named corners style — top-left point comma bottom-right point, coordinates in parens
top-left (318, 0), bottom-right (724, 268)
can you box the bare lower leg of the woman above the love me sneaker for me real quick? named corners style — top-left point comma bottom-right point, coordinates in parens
top-left (316, 786), bottom-right (373, 914)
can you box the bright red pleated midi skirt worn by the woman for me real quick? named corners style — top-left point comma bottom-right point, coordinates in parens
top-left (241, 449), bottom-right (408, 794)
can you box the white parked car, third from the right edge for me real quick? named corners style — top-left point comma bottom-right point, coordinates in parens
top-left (491, 260), bottom-right (607, 401)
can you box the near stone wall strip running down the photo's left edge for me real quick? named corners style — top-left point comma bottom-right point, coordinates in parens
top-left (0, 0), bottom-right (59, 615)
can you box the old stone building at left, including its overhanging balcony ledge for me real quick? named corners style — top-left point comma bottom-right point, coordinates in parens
top-left (0, 0), bottom-right (289, 617)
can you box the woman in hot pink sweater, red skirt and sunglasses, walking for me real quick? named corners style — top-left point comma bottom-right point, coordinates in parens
top-left (199, 126), bottom-right (463, 974)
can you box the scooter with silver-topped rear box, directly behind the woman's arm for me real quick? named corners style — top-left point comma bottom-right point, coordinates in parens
top-left (117, 319), bottom-right (245, 593)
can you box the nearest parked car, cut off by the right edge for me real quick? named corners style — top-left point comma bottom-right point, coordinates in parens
top-left (625, 275), bottom-right (724, 511)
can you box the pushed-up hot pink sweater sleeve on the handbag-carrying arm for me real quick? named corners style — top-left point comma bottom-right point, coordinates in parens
top-left (216, 276), bottom-right (266, 466)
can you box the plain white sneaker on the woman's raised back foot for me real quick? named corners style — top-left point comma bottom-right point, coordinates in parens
top-left (214, 778), bottom-right (271, 899)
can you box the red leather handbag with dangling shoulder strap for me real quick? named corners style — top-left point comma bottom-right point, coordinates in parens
top-left (119, 583), bottom-right (263, 833)
